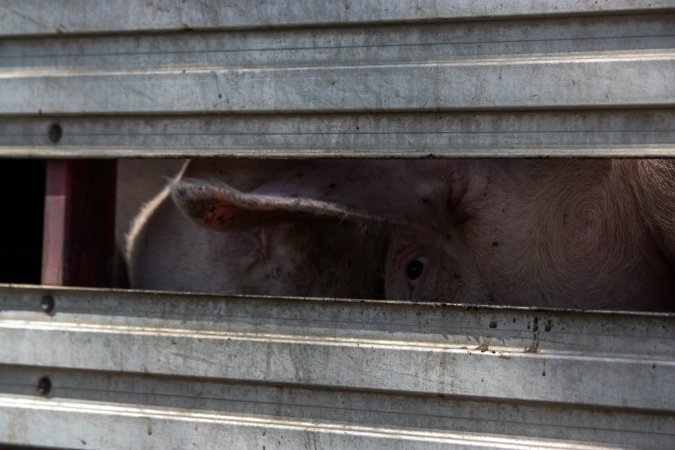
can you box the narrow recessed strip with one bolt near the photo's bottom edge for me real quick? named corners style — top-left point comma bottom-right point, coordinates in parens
top-left (0, 366), bottom-right (675, 449)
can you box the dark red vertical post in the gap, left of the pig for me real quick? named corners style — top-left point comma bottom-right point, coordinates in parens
top-left (42, 160), bottom-right (117, 287)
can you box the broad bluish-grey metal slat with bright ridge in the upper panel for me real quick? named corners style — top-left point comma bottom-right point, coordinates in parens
top-left (0, 14), bottom-right (675, 114)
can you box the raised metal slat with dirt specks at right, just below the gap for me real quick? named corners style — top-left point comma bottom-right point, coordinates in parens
top-left (0, 290), bottom-right (675, 404)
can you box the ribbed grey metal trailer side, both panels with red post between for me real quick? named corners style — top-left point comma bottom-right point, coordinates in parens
top-left (0, 0), bottom-right (675, 449)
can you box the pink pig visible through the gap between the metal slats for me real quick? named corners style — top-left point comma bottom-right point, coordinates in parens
top-left (129, 159), bottom-right (675, 310)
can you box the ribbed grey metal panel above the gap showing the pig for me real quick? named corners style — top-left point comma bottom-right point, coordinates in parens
top-left (0, 9), bottom-right (675, 158)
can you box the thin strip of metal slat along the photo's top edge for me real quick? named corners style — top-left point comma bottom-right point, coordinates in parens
top-left (0, 0), bottom-right (675, 36)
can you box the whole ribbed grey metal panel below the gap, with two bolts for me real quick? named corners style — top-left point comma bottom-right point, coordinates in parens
top-left (0, 286), bottom-right (675, 448)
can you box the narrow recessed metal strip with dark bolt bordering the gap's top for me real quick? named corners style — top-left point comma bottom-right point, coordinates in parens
top-left (0, 109), bottom-right (675, 158)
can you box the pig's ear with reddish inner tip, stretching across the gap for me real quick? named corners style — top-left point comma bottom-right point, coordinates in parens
top-left (171, 178), bottom-right (384, 230)
